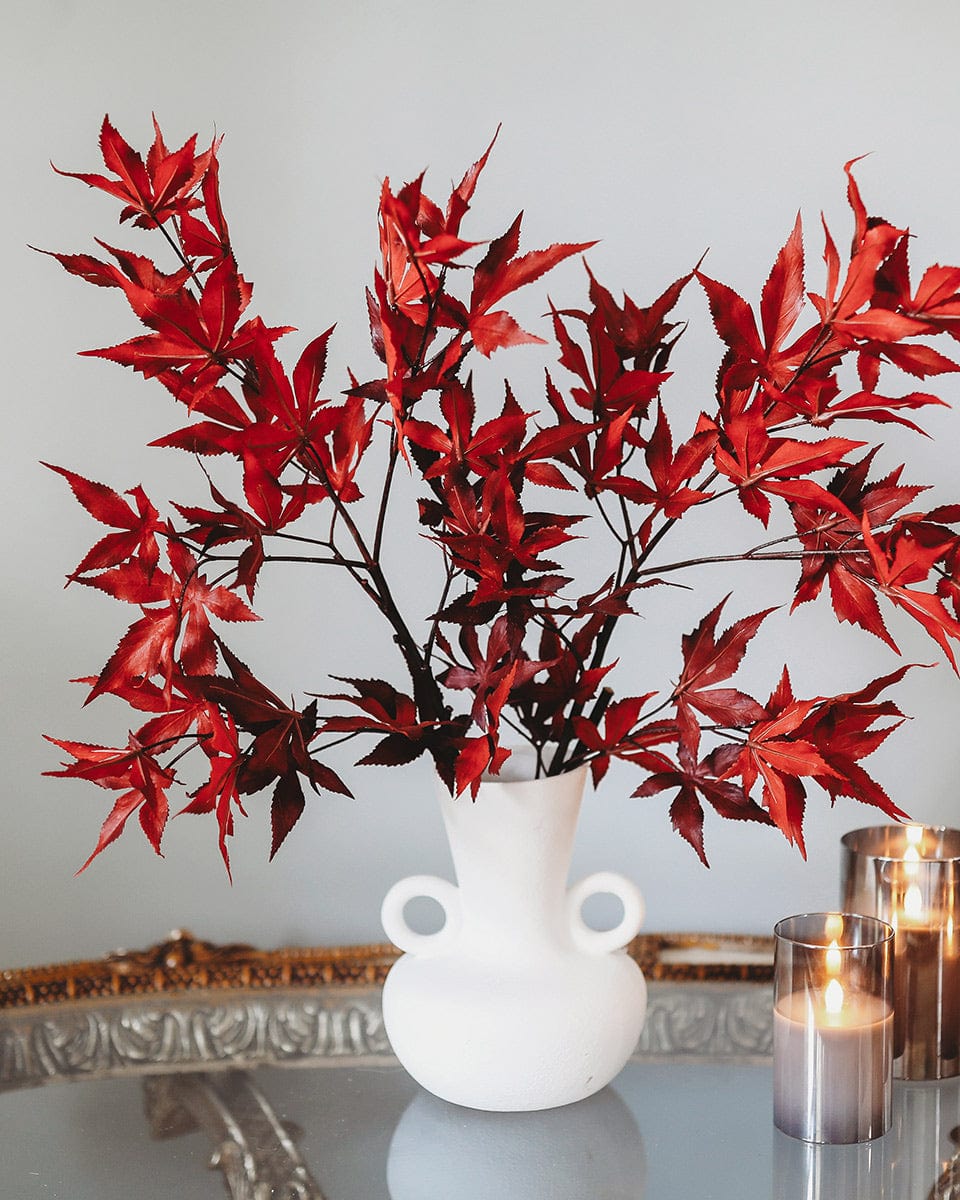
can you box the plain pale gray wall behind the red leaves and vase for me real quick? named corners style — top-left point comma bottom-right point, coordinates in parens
top-left (0, 0), bottom-right (960, 965)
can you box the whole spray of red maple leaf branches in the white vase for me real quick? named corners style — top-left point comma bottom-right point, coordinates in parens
top-left (43, 120), bottom-right (960, 866)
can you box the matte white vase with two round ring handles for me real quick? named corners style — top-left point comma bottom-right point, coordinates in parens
top-left (382, 768), bottom-right (647, 1111)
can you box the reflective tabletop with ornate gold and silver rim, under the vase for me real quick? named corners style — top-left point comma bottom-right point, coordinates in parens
top-left (0, 926), bottom-right (960, 1200)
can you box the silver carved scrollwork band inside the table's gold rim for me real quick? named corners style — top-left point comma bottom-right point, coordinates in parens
top-left (0, 982), bottom-right (773, 1091)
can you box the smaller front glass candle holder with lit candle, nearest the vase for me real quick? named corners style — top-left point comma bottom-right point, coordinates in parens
top-left (773, 912), bottom-right (894, 1145)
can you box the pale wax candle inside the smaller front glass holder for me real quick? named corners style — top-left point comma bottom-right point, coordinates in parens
top-left (773, 980), bottom-right (893, 1144)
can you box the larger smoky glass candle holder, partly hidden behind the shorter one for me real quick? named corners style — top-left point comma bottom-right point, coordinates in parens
top-left (841, 826), bottom-right (960, 1080)
